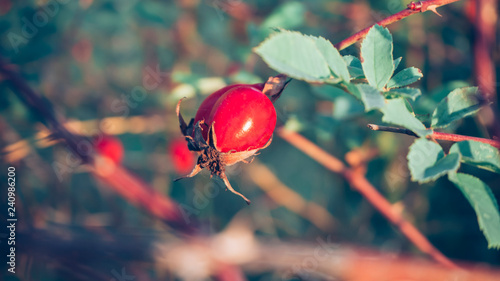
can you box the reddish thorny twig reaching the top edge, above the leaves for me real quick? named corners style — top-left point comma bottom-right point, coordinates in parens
top-left (335, 0), bottom-right (459, 50)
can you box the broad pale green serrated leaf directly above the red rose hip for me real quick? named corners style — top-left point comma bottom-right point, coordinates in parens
top-left (254, 31), bottom-right (330, 82)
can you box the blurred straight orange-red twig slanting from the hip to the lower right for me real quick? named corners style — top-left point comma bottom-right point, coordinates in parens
top-left (278, 127), bottom-right (457, 268)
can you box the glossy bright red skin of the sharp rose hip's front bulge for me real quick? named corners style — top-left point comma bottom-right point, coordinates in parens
top-left (206, 85), bottom-right (276, 153)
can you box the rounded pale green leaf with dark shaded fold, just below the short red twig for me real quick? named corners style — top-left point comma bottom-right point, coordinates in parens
top-left (407, 138), bottom-right (460, 183)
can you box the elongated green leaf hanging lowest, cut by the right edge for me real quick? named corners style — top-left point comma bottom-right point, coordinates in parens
top-left (448, 173), bottom-right (500, 249)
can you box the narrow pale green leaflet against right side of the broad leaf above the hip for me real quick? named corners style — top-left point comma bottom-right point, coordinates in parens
top-left (311, 36), bottom-right (350, 82)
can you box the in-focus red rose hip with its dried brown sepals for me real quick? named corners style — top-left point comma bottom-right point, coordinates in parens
top-left (177, 81), bottom-right (276, 204)
